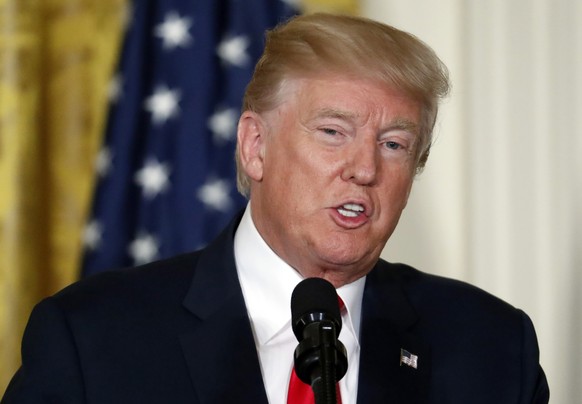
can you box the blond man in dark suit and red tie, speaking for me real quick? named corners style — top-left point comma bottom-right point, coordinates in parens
top-left (2, 15), bottom-right (549, 404)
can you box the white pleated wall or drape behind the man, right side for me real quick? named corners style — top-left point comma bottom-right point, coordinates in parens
top-left (362, 0), bottom-right (582, 404)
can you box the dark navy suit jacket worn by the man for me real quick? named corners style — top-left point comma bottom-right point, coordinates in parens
top-left (2, 218), bottom-right (549, 404)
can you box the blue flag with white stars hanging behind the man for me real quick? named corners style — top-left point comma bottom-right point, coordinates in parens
top-left (82, 0), bottom-right (296, 275)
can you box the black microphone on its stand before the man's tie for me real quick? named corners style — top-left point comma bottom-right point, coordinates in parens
top-left (291, 278), bottom-right (348, 404)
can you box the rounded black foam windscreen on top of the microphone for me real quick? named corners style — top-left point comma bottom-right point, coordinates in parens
top-left (291, 278), bottom-right (342, 338)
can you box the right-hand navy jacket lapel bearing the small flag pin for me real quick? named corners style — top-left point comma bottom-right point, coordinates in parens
top-left (358, 261), bottom-right (430, 403)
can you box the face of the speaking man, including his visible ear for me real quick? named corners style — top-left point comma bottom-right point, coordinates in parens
top-left (239, 76), bottom-right (420, 287)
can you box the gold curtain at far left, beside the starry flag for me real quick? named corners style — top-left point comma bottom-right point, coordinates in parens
top-left (0, 0), bottom-right (126, 395)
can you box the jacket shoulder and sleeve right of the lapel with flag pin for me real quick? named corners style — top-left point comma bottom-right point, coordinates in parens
top-left (370, 262), bottom-right (548, 403)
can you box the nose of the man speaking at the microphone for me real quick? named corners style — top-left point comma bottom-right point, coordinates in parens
top-left (341, 139), bottom-right (380, 185)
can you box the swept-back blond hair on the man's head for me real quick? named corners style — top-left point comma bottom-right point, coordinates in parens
top-left (236, 13), bottom-right (449, 196)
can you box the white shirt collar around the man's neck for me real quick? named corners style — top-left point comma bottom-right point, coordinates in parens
top-left (234, 204), bottom-right (365, 345)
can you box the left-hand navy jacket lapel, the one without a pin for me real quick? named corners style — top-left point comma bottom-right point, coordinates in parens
top-left (180, 217), bottom-right (267, 404)
